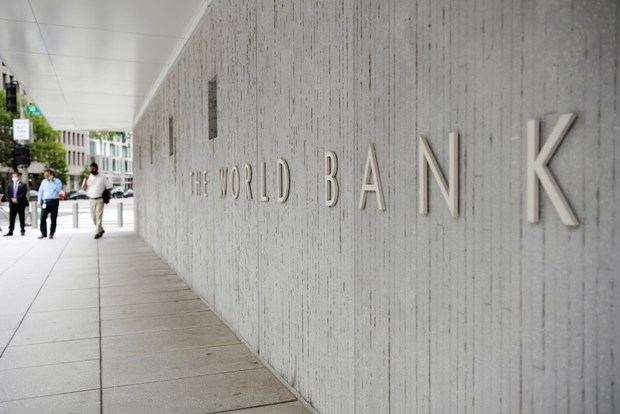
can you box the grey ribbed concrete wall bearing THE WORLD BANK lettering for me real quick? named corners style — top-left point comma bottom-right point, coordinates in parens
top-left (134, 0), bottom-right (620, 413)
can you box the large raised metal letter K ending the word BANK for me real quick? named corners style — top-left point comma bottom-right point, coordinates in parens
top-left (527, 113), bottom-right (579, 226)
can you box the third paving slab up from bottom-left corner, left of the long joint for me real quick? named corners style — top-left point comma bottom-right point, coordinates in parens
top-left (0, 338), bottom-right (99, 371)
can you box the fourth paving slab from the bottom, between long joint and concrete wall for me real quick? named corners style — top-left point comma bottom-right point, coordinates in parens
top-left (101, 311), bottom-right (222, 337)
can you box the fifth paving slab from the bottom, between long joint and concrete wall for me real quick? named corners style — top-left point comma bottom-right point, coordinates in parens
top-left (101, 299), bottom-right (209, 321)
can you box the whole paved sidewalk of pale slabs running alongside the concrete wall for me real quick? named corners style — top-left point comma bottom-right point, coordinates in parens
top-left (0, 229), bottom-right (306, 414)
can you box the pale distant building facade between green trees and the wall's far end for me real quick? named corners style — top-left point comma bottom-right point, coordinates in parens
top-left (89, 132), bottom-right (133, 190)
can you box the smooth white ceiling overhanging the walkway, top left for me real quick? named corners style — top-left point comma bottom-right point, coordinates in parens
top-left (0, 0), bottom-right (210, 130)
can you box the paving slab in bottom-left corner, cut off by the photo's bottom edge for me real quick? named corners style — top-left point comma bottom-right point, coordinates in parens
top-left (0, 390), bottom-right (101, 414)
